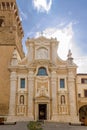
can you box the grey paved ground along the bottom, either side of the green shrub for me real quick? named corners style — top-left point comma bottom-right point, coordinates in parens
top-left (0, 122), bottom-right (87, 130)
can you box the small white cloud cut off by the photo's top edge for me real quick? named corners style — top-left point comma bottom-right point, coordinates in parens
top-left (33, 0), bottom-right (52, 13)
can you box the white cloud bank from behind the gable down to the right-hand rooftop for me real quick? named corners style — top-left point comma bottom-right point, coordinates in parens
top-left (36, 23), bottom-right (87, 73)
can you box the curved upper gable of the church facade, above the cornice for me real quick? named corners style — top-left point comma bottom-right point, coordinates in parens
top-left (12, 36), bottom-right (76, 68)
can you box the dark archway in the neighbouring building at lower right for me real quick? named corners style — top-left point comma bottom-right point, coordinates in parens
top-left (79, 105), bottom-right (87, 122)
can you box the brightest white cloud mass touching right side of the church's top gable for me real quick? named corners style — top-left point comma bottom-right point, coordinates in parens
top-left (37, 23), bottom-right (73, 60)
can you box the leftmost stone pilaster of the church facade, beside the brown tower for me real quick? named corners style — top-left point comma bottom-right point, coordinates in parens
top-left (9, 72), bottom-right (17, 116)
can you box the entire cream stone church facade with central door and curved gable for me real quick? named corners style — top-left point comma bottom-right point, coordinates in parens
top-left (9, 36), bottom-right (79, 122)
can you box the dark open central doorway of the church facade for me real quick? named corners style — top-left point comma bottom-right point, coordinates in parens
top-left (38, 104), bottom-right (47, 120)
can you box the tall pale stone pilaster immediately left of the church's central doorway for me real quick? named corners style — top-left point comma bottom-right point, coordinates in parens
top-left (28, 71), bottom-right (34, 120)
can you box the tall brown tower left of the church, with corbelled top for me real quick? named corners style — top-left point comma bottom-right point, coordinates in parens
top-left (0, 0), bottom-right (24, 115)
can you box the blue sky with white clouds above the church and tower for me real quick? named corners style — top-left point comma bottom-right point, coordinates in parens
top-left (17, 0), bottom-right (87, 72)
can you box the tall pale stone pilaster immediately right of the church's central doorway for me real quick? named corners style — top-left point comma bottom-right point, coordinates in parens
top-left (51, 71), bottom-right (58, 120)
